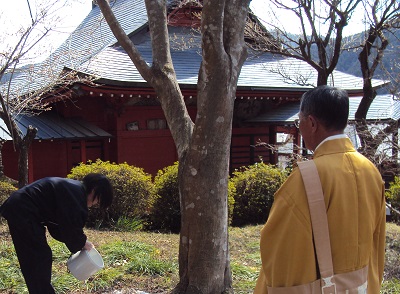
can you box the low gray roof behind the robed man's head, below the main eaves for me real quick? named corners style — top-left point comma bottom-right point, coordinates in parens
top-left (248, 95), bottom-right (400, 124)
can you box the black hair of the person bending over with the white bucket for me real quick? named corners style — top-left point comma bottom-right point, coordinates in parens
top-left (82, 173), bottom-right (113, 210)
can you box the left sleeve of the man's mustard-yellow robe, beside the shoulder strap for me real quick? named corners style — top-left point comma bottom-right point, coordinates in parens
top-left (254, 169), bottom-right (317, 293)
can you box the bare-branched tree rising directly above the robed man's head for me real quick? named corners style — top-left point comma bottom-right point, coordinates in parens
top-left (246, 0), bottom-right (361, 86)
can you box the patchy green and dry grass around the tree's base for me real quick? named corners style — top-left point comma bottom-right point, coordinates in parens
top-left (0, 222), bottom-right (400, 294)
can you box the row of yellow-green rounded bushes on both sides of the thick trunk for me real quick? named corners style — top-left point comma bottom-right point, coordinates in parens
top-left (63, 160), bottom-right (287, 233)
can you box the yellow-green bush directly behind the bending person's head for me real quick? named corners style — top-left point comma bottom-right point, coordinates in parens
top-left (67, 160), bottom-right (154, 227)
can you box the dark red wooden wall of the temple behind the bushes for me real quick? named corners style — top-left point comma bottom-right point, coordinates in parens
top-left (3, 93), bottom-right (274, 181)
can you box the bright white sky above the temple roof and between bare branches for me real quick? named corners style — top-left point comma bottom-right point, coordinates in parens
top-left (0, 0), bottom-right (364, 63)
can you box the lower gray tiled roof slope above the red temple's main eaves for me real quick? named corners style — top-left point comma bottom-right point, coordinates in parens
top-left (81, 23), bottom-right (383, 91)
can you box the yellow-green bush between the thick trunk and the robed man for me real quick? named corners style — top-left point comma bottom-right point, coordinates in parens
top-left (230, 163), bottom-right (287, 226)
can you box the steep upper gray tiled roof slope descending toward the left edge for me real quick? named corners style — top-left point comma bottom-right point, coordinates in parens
top-left (0, 0), bottom-right (147, 95)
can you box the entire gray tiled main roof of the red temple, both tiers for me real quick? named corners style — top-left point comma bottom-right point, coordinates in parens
top-left (2, 0), bottom-right (383, 99)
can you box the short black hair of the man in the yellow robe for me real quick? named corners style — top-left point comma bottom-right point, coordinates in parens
top-left (300, 86), bottom-right (349, 131)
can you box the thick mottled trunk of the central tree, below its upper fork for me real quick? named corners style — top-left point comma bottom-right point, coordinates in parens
top-left (178, 72), bottom-right (235, 293)
